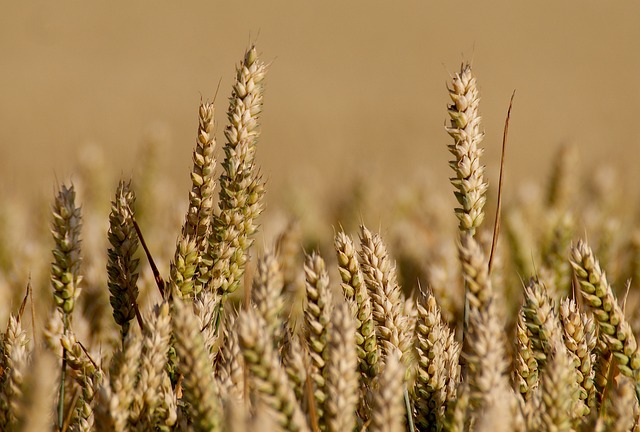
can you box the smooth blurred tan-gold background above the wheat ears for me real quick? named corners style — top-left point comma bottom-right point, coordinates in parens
top-left (0, 1), bottom-right (640, 223)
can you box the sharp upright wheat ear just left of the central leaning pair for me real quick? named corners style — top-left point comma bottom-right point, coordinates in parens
top-left (304, 252), bottom-right (332, 428)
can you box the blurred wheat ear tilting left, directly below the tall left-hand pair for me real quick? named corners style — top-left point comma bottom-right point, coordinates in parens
top-left (171, 298), bottom-right (222, 431)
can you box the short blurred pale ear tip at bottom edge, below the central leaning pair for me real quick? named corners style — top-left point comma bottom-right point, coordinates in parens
top-left (369, 350), bottom-right (406, 432)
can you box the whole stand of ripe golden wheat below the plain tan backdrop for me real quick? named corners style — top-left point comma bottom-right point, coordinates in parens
top-left (0, 37), bottom-right (640, 432)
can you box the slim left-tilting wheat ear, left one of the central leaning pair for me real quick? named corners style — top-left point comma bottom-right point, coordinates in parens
top-left (334, 231), bottom-right (378, 380)
